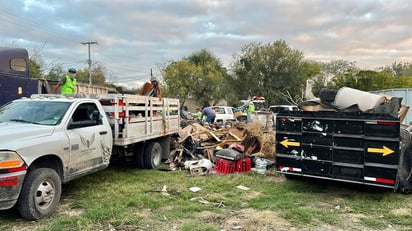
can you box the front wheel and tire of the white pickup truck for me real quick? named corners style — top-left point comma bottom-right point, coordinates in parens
top-left (17, 168), bottom-right (62, 220)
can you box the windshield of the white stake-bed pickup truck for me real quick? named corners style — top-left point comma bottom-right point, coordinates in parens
top-left (0, 101), bottom-right (71, 125)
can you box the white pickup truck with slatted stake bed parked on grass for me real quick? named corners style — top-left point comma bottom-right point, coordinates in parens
top-left (0, 94), bottom-right (180, 220)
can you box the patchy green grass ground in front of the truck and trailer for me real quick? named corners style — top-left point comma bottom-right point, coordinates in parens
top-left (0, 167), bottom-right (412, 231)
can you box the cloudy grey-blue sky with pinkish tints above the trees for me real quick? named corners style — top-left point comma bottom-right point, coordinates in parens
top-left (0, 0), bottom-right (412, 86)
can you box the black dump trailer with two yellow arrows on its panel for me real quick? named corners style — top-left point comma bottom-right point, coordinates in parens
top-left (276, 111), bottom-right (412, 193)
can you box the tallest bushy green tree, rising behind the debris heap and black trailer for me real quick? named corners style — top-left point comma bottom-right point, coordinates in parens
top-left (232, 40), bottom-right (311, 104)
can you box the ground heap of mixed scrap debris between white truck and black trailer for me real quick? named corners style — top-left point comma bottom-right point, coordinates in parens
top-left (167, 122), bottom-right (275, 173)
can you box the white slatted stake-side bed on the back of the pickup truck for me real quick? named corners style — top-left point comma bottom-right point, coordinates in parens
top-left (91, 94), bottom-right (180, 146)
